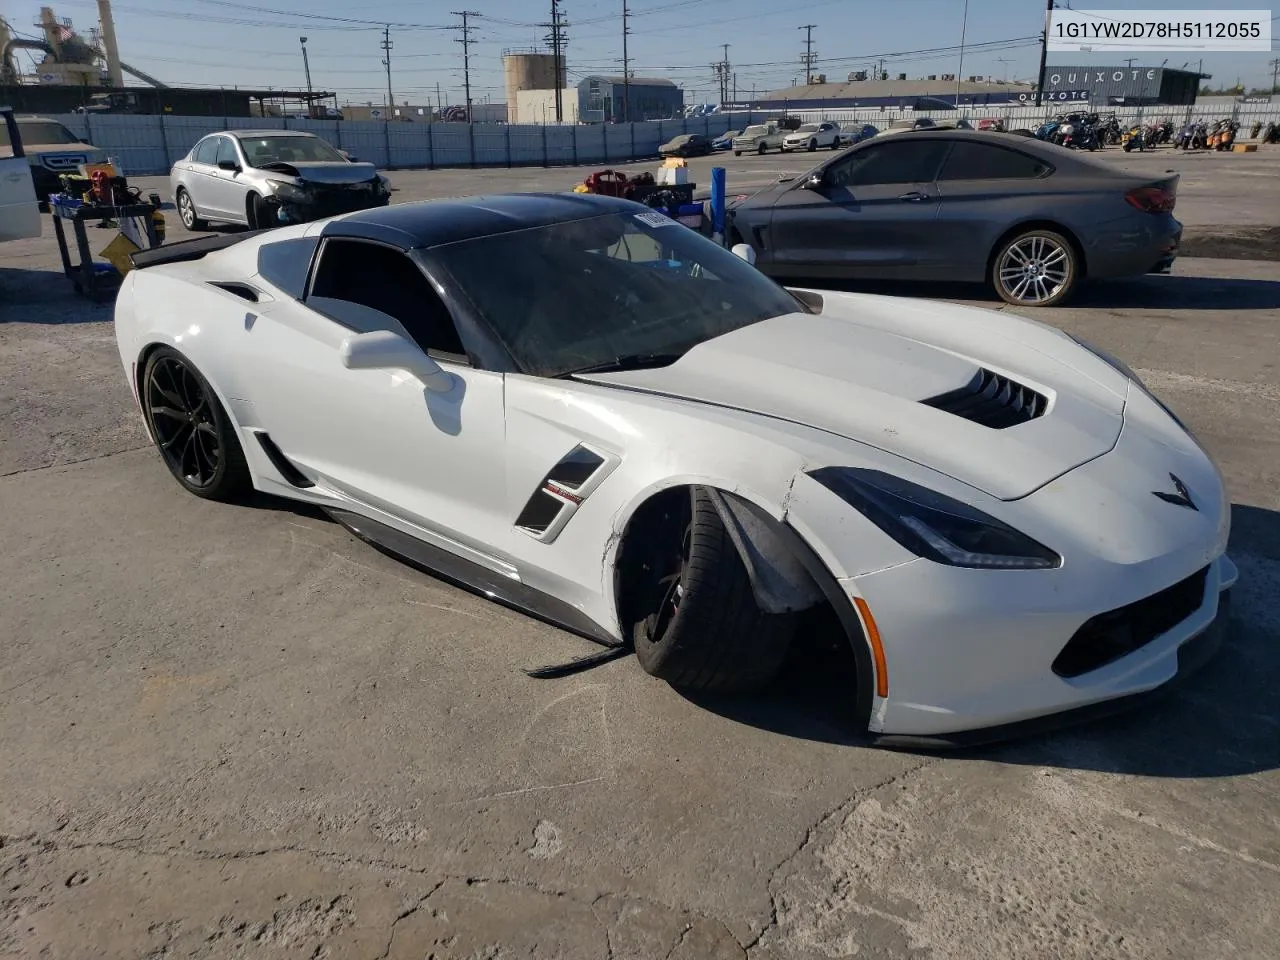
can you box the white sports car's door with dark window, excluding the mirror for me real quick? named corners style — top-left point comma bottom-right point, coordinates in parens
top-left (244, 238), bottom-right (515, 576)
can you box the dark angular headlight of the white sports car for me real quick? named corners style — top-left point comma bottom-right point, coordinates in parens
top-left (809, 467), bottom-right (1062, 570)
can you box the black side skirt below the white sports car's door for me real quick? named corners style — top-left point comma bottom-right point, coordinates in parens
top-left (324, 507), bottom-right (625, 646)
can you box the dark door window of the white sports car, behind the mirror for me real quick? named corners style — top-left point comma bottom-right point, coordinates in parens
top-left (308, 239), bottom-right (466, 358)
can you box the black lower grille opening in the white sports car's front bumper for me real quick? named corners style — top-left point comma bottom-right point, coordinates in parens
top-left (1053, 567), bottom-right (1208, 677)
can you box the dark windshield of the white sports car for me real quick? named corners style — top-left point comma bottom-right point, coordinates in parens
top-left (426, 209), bottom-right (804, 376)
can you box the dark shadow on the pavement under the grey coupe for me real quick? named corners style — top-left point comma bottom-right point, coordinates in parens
top-left (786, 274), bottom-right (1280, 316)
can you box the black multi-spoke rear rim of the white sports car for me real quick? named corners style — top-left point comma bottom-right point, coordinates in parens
top-left (146, 357), bottom-right (223, 488)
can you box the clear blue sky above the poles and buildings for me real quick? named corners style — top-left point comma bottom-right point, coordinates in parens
top-left (4, 0), bottom-right (1280, 104)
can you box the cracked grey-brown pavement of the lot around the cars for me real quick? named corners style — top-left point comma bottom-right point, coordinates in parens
top-left (0, 148), bottom-right (1280, 960)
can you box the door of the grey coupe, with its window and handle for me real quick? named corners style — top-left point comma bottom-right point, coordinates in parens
top-left (762, 133), bottom-right (947, 279)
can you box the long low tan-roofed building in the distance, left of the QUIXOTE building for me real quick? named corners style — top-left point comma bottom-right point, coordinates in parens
top-left (752, 70), bottom-right (1033, 110)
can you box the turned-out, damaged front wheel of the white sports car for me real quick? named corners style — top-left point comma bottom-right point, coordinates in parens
top-left (632, 486), bottom-right (796, 694)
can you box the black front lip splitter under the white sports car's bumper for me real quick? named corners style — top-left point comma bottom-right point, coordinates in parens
top-left (870, 590), bottom-right (1231, 750)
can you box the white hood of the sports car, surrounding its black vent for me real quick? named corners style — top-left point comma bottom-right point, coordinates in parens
top-left (582, 292), bottom-right (1129, 500)
